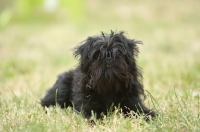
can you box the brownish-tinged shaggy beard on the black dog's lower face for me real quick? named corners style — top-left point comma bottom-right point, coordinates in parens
top-left (88, 57), bottom-right (132, 93)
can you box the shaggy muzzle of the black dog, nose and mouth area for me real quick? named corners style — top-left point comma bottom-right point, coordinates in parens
top-left (89, 57), bottom-right (129, 82)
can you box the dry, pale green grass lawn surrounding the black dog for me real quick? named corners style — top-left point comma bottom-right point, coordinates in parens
top-left (0, 0), bottom-right (200, 132)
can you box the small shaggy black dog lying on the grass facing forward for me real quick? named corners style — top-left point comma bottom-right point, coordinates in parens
top-left (41, 31), bottom-right (155, 118)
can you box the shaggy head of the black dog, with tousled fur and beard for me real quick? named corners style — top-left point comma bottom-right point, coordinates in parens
top-left (75, 31), bottom-right (143, 94)
